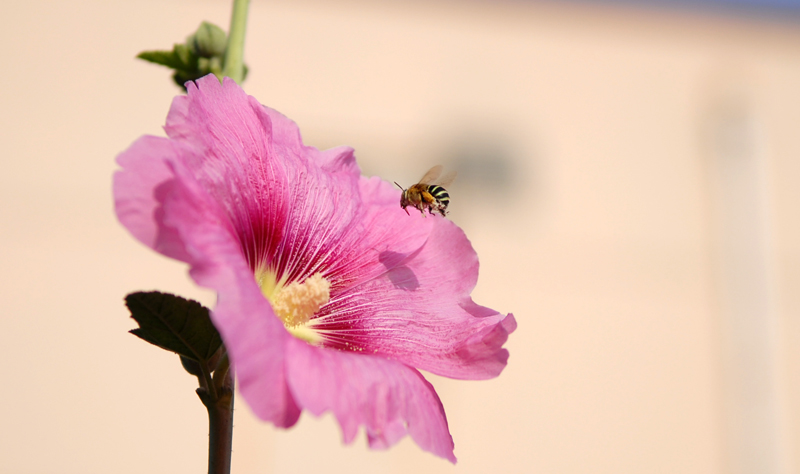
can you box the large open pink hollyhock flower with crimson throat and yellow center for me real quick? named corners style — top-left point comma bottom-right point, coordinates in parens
top-left (114, 76), bottom-right (516, 462)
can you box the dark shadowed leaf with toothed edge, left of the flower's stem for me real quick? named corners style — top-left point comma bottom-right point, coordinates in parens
top-left (125, 291), bottom-right (222, 364)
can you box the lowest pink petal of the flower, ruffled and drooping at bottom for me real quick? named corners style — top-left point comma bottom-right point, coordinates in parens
top-left (287, 339), bottom-right (456, 462)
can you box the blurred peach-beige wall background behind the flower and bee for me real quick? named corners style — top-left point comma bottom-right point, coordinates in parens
top-left (0, 0), bottom-right (800, 474)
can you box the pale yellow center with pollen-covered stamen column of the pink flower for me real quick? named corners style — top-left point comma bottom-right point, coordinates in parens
top-left (256, 271), bottom-right (331, 343)
